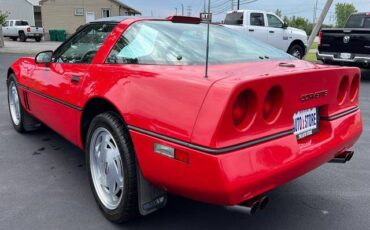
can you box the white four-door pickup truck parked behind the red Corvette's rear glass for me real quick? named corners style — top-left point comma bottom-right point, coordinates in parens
top-left (224, 10), bottom-right (308, 59)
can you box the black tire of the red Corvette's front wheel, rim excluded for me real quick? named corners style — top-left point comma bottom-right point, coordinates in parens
top-left (7, 74), bottom-right (41, 133)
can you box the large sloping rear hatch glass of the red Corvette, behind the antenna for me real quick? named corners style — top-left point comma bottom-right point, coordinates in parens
top-left (107, 21), bottom-right (294, 65)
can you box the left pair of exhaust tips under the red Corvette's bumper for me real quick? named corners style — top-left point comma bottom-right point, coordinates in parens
top-left (227, 196), bottom-right (269, 216)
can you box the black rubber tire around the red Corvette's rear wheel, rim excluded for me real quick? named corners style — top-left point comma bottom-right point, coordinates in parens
top-left (85, 112), bottom-right (139, 223)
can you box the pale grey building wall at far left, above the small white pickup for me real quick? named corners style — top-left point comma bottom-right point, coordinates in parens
top-left (0, 0), bottom-right (35, 26)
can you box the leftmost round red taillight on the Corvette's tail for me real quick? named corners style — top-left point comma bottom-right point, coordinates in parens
top-left (232, 90), bottom-right (257, 131)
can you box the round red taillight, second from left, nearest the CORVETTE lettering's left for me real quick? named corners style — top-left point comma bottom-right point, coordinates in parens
top-left (262, 86), bottom-right (283, 123)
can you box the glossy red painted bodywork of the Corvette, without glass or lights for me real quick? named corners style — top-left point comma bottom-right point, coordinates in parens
top-left (7, 19), bottom-right (362, 205)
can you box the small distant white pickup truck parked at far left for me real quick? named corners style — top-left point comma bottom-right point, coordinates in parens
top-left (3, 20), bottom-right (44, 42)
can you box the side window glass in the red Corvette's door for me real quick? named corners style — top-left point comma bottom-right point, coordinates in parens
top-left (53, 23), bottom-right (115, 64)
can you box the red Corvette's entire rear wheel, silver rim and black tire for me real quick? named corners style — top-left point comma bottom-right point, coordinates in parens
top-left (86, 112), bottom-right (139, 223)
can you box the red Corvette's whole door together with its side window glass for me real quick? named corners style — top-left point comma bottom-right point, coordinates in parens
top-left (28, 23), bottom-right (115, 143)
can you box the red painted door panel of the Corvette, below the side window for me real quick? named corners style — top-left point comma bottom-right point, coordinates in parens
top-left (28, 63), bottom-right (90, 142)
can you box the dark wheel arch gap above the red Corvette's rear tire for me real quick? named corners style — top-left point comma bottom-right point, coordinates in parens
top-left (80, 97), bottom-right (126, 147)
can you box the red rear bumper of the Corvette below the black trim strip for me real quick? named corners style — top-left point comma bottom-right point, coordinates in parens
top-left (130, 110), bottom-right (362, 205)
